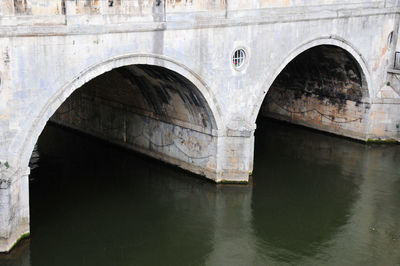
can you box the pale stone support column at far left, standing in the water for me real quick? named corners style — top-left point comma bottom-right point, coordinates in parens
top-left (0, 167), bottom-right (29, 252)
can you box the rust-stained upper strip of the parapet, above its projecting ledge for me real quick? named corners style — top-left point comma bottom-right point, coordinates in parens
top-left (0, 0), bottom-right (390, 16)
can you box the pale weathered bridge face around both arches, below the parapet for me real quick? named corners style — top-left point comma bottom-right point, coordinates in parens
top-left (0, 6), bottom-right (396, 179)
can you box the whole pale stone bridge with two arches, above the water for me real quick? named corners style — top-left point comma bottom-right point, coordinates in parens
top-left (0, 0), bottom-right (400, 254)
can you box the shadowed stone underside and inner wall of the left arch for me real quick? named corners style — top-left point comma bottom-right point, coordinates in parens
top-left (50, 64), bottom-right (217, 178)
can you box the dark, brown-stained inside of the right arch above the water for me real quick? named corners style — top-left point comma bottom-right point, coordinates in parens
top-left (258, 44), bottom-right (369, 140)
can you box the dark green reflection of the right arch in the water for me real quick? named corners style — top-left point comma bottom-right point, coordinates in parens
top-left (252, 120), bottom-right (365, 264)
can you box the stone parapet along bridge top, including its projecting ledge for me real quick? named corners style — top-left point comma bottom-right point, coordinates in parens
top-left (0, 0), bottom-right (400, 26)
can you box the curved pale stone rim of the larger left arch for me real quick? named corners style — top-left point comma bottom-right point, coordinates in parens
top-left (17, 54), bottom-right (222, 166)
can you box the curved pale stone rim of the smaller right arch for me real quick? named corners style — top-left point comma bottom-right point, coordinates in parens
top-left (250, 35), bottom-right (372, 124)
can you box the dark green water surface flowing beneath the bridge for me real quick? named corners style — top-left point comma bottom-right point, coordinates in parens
top-left (0, 121), bottom-right (400, 266)
